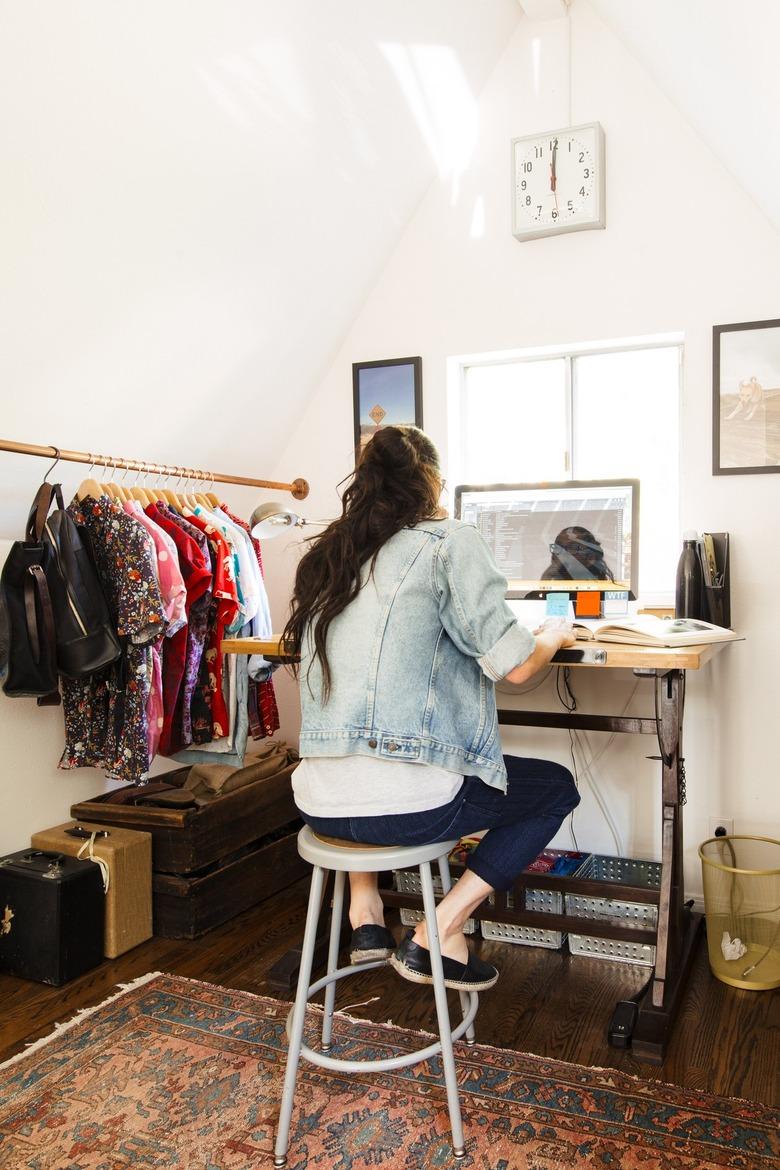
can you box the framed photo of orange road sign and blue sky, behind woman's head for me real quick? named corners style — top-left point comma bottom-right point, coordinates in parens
top-left (352, 358), bottom-right (422, 463)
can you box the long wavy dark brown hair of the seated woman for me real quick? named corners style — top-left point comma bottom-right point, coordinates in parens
top-left (282, 426), bottom-right (441, 700)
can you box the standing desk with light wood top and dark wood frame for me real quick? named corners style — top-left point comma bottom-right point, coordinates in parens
top-left (222, 639), bottom-right (726, 1064)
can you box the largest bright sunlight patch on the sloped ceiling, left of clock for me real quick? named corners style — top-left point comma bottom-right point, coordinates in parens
top-left (379, 43), bottom-right (478, 206)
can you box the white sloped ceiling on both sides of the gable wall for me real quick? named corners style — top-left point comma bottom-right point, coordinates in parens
top-left (0, 0), bottom-right (780, 507)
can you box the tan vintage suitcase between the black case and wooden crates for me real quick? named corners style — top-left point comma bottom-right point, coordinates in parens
top-left (32, 820), bottom-right (152, 958)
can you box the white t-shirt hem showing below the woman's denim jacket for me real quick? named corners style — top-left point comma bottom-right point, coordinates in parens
top-left (292, 756), bottom-right (463, 817)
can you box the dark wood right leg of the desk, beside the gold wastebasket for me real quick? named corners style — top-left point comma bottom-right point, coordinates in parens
top-left (631, 670), bottom-right (702, 1064)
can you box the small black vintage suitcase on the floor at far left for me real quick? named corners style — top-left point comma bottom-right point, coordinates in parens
top-left (0, 849), bottom-right (105, 986)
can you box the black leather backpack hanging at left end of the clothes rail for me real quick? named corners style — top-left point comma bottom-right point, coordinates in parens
top-left (0, 482), bottom-right (122, 703)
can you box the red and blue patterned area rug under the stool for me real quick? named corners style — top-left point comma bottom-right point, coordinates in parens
top-left (0, 975), bottom-right (780, 1170)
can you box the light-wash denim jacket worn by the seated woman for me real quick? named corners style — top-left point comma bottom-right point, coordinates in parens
top-left (295, 519), bottom-right (534, 789)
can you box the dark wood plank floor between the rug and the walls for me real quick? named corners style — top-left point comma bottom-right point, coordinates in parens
top-left (0, 882), bottom-right (780, 1106)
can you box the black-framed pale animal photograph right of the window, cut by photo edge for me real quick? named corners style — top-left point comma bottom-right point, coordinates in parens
top-left (712, 321), bottom-right (780, 475)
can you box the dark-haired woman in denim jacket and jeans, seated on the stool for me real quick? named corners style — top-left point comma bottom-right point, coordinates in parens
top-left (283, 426), bottom-right (579, 991)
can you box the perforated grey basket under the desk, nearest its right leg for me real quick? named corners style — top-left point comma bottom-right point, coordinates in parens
top-left (566, 853), bottom-right (661, 966)
